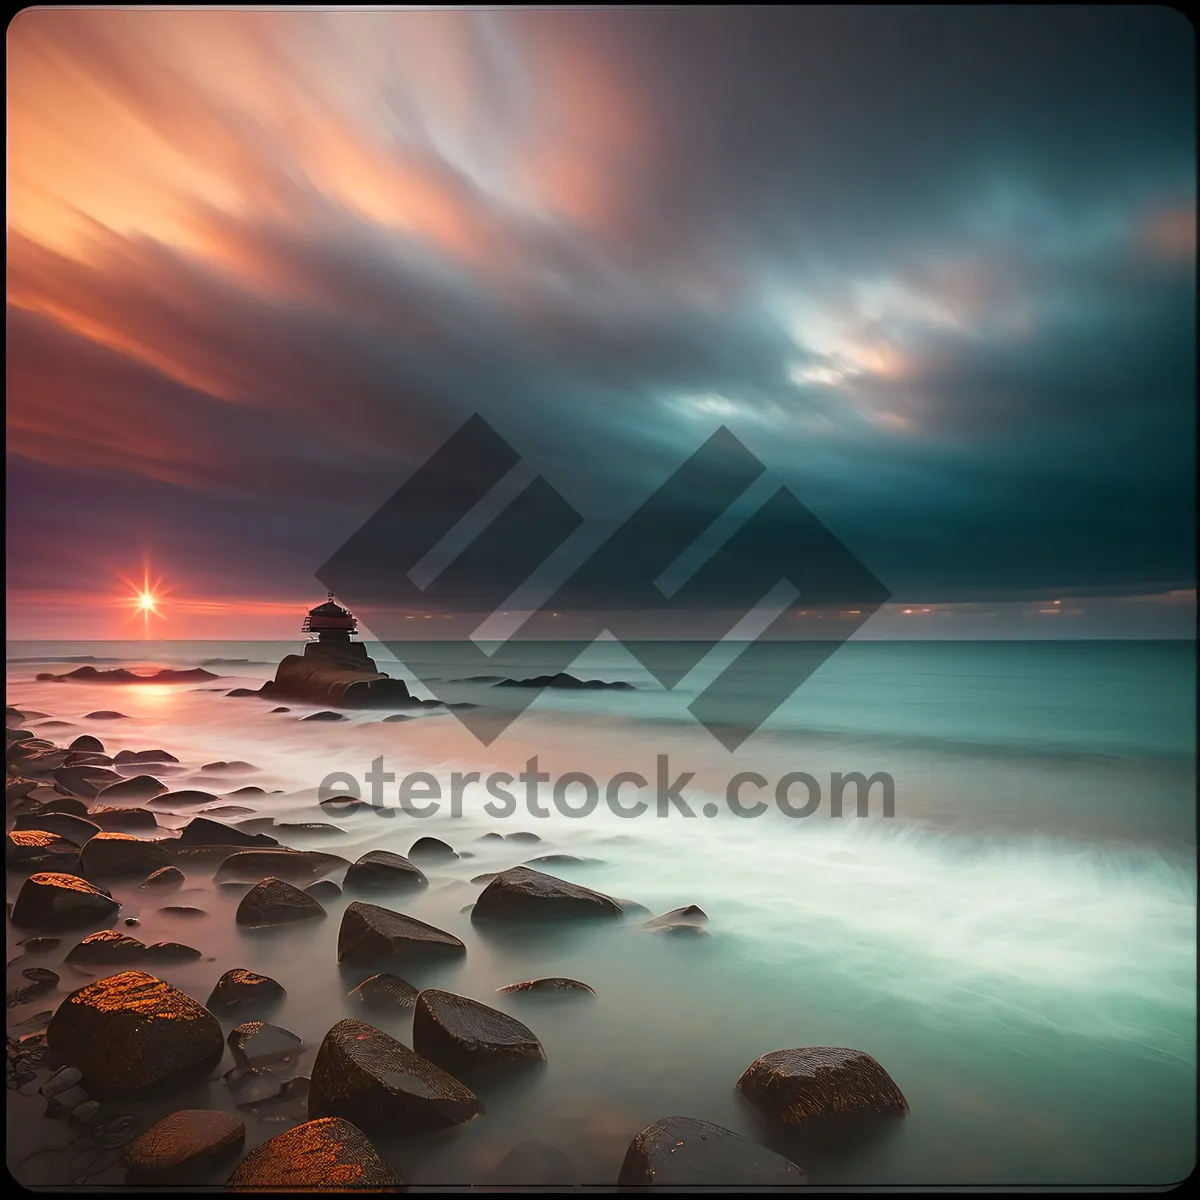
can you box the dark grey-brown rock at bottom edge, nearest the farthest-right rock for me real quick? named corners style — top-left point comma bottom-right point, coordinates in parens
top-left (617, 1117), bottom-right (808, 1189)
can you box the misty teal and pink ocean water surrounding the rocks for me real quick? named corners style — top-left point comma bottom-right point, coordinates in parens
top-left (7, 641), bottom-right (1196, 1187)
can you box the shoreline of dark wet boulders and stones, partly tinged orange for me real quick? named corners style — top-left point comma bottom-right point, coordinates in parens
top-left (5, 700), bottom-right (908, 1190)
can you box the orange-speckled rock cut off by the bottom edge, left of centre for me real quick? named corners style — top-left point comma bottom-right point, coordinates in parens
top-left (226, 1118), bottom-right (404, 1193)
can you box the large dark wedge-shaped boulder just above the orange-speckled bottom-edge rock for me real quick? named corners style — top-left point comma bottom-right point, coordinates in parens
top-left (308, 1020), bottom-right (484, 1135)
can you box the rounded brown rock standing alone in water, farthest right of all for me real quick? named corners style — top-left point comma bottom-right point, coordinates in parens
top-left (738, 1046), bottom-right (908, 1126)
